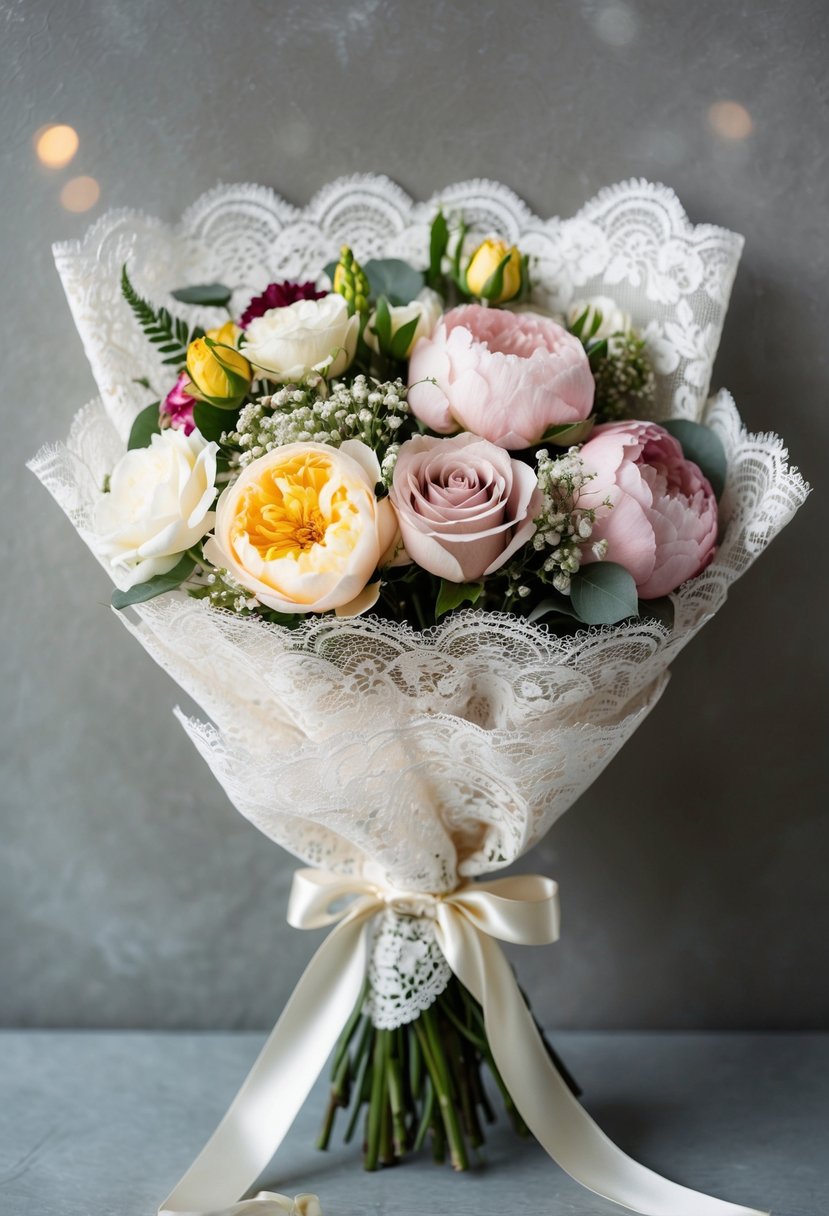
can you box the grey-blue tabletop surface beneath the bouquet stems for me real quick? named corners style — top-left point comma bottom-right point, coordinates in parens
top-left (0, 1031), bottom-right (829, 1216)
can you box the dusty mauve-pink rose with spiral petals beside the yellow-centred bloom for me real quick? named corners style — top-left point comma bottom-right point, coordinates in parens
top-left (389, 433), bottom-right (543, 582)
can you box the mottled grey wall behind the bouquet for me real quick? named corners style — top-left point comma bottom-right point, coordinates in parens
top-left (0, 0), bottom-right (829, 1028)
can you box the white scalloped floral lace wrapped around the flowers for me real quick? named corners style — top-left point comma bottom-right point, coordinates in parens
top-left (32, 178), bottom-right (807, 1028)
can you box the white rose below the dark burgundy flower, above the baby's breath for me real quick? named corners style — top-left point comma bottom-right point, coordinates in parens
top-left (242, 292), bottom-right (360, 382)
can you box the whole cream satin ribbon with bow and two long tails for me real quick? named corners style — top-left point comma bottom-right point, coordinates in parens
top-left (159, 869), bottom-right (767, 1216)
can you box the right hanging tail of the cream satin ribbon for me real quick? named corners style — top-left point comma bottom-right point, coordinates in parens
top-left (438, 905), bottom-right (767, 1216)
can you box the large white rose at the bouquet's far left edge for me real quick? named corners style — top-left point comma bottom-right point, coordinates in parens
top-left (92, 428), bottom-right (219, 591)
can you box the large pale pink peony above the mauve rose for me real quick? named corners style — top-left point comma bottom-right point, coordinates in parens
top-left (408, 304), bottom-right (594, 450)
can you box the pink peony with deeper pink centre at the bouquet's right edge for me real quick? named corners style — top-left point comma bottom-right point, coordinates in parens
top-left (579, 422), bottom-right (717, 599)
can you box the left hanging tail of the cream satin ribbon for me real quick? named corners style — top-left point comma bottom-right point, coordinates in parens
top-left (159, 910), bottom-right (370, 1216)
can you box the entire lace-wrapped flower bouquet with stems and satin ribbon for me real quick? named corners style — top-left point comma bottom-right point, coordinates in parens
top-left (32, 178), bottom-right (807, 1216)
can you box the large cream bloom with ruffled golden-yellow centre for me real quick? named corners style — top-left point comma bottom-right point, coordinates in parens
top-left (204, 439), bottom-right (397, 617)
